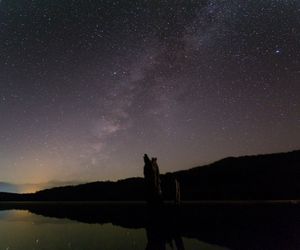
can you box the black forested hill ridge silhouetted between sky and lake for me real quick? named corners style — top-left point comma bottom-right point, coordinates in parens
top-left (0, 150), bottom-right (300, 201)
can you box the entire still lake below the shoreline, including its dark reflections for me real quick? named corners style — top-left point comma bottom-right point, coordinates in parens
top-left (0, 203), bottom-right (300, 250)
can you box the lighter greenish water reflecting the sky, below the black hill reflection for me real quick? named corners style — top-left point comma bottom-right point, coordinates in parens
top-left (0, 210), bottom-right (228, 250)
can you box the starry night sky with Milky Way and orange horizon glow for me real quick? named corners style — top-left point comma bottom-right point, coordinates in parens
top-left (0, 0), bottom-right (300, 183)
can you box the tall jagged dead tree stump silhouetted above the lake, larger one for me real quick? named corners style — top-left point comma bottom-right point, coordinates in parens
top-left (144, 154), bottom-right (162, 204)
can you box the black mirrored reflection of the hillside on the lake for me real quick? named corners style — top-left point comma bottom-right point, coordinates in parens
top-left (0, 203), bottom-right (300, 250)
